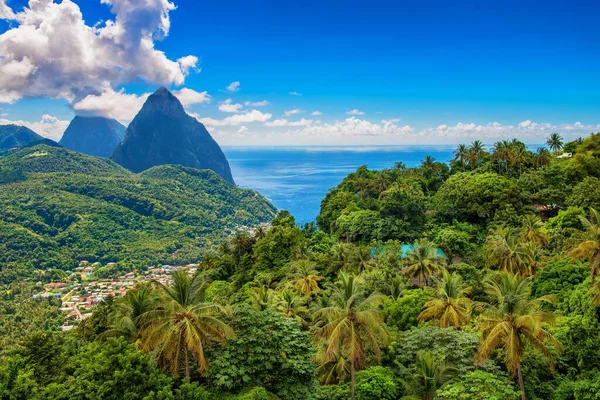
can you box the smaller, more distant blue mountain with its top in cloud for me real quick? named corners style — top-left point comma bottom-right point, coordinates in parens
top-left (59, 116), bottom-right (125, 157)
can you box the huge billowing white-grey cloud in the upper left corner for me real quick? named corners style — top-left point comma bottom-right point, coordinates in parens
top-left (0, 0), bottom-right (198, 103)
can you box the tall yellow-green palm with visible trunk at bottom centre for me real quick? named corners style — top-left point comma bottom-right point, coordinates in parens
top-left (315, 272), bottom-right (389, 400)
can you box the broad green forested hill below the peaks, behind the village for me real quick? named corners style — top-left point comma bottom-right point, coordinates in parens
top-left (0, 145), bottom-right (275, 282)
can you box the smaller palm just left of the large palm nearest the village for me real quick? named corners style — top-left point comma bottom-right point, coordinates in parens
top-left (100, 284), bottom-right (159, 345)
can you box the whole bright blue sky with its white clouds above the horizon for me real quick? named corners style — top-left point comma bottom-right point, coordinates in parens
top-left (0, 0), bottom-right (600, 146)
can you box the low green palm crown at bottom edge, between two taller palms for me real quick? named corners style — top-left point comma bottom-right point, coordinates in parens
top-left (403, 351), bottom-right (458, 400)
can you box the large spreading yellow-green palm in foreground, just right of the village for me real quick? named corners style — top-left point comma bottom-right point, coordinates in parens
top-left (140, 270), bottom-right (233, 381)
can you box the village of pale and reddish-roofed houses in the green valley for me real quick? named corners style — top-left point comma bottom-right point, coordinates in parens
top-left (33, 261), bottom-right (198, 331)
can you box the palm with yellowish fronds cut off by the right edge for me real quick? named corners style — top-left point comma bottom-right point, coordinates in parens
top-left (567, 208), bottom-right (600, 306)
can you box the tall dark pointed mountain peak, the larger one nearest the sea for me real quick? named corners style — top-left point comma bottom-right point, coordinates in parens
top-left (112, 87), bottom-right (233, 183)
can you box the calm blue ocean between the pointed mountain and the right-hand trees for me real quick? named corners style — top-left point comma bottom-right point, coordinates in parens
top-left (223, 146), bottom-right (456, 223)
